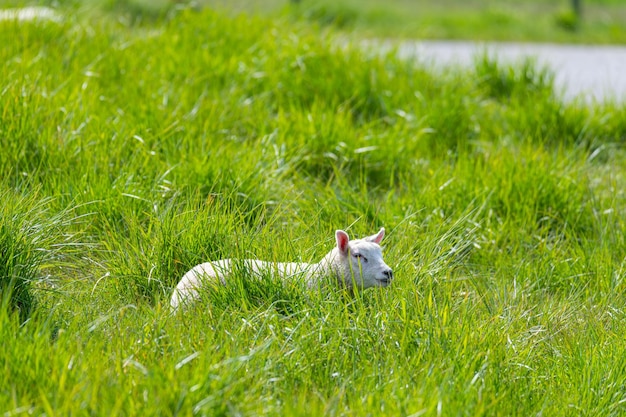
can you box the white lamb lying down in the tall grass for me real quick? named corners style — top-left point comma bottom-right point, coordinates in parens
top-left (170, 228), bottom-right (393, 310)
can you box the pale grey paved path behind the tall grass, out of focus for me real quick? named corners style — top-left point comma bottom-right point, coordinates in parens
top-left (390, 41), bottom-right (626, 103)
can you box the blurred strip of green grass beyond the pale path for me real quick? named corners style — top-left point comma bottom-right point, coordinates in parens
top-left (188, 0), bottom-right (626, 44)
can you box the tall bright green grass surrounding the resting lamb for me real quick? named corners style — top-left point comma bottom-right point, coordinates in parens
top-left (0, 1), bottom-right (626, 417)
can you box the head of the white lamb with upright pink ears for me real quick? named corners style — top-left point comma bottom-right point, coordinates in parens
top-left (329, 228), bottom-right (393, 289)
